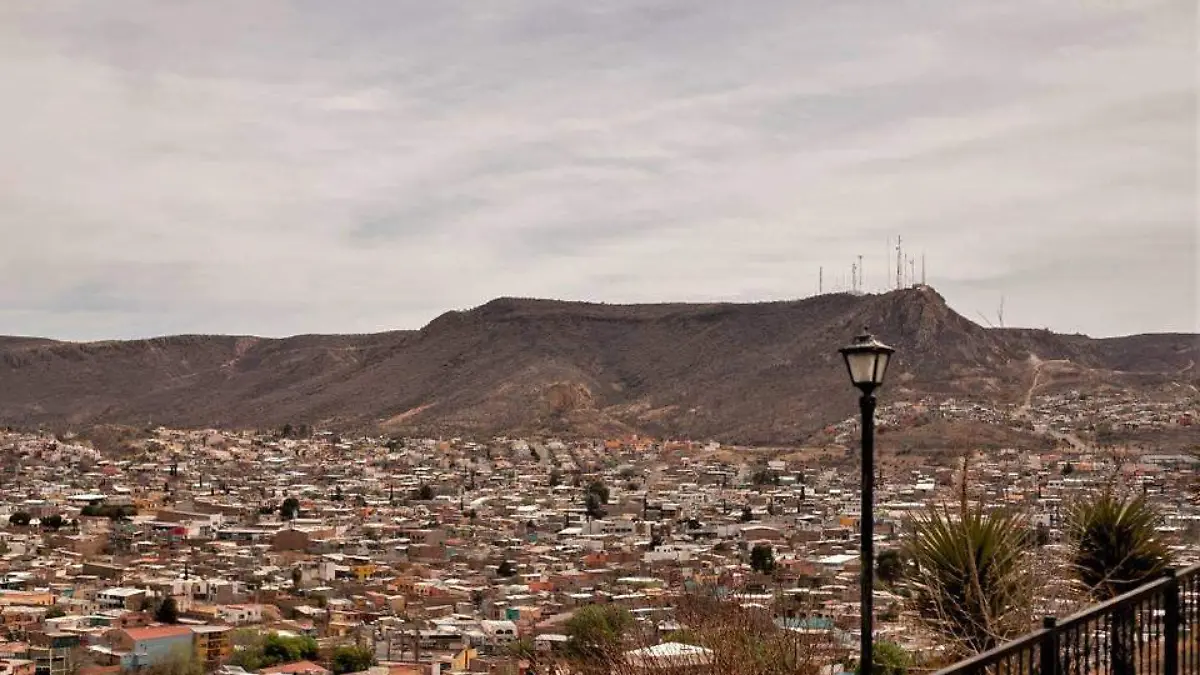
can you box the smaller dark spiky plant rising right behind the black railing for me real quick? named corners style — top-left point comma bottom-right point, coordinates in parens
top-left (1067, 490), bottom-right (1171, 593)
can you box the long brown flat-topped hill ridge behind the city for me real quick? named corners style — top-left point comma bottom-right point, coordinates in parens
top-left (0, 287), bottom-right (1200, 443)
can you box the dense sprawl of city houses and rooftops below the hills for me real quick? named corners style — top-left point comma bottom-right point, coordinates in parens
top-left (0, 399), bottom-right (1200, 675)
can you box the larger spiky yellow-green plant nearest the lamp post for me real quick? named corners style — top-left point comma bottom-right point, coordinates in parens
top-left (905, 502), bottom-right (1033, 653)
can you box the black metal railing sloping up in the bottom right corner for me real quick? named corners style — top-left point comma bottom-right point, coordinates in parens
top-left (936, 565), bottom-right (1200, 675)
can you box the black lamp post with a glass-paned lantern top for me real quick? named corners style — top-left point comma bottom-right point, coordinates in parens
top-left (838, 329), bottom-right (895, 675)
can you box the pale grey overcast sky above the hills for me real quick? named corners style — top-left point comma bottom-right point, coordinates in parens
top-left (0, 0), bottom-right (1200, 340)
